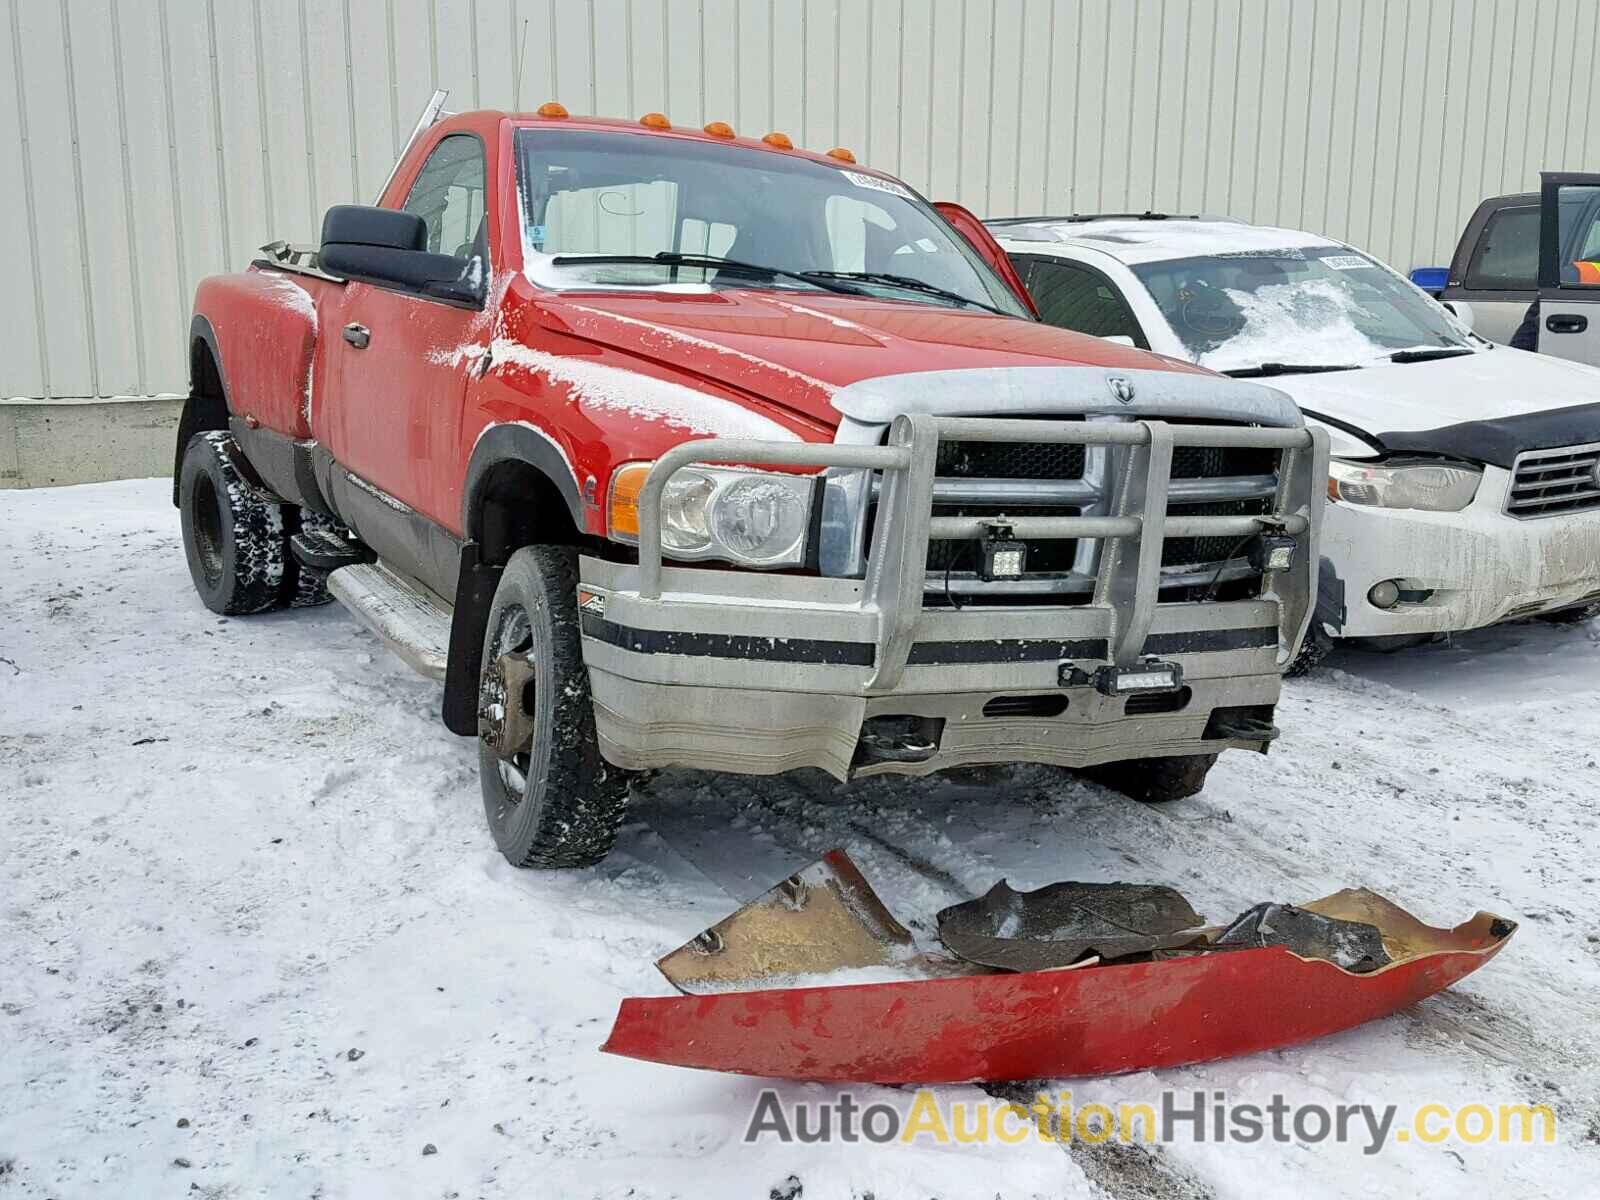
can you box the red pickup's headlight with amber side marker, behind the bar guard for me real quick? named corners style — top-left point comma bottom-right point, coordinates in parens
top-left (608, 462), bottom-right (816, 566)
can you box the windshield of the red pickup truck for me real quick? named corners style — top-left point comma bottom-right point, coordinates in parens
top-left (517, 130), bottom-right (1029, 317)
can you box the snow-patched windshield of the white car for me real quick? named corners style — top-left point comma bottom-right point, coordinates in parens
top-left (1133, 246), bottom-right (1472, 371)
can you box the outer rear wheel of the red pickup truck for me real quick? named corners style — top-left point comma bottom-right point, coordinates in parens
top-left (178, 429), bottom-right (288, 616)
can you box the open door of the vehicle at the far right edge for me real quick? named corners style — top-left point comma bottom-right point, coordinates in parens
top-left (1539, 171), bottom-right (1600, 365)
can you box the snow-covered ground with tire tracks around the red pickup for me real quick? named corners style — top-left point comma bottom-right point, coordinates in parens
top-left (9, 480), bottom-right (1600, 1200)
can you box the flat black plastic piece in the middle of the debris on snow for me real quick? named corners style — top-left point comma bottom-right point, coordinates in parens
top-left (939, 880), bottom-right (1205, 971)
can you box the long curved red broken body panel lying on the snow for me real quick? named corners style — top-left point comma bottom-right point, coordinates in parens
top-left (603, 857), bottom-right (1515, 1083)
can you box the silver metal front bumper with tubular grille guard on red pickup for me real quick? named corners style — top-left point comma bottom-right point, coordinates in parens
top-left (579, 414), bottom-right (1326, 778)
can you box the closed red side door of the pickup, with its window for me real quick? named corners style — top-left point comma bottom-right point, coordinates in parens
top-left (318, 133), bottom-right (490, 544)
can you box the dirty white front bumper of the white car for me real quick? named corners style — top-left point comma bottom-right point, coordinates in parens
top-left (1317, 467), bottom-right (1600, 637)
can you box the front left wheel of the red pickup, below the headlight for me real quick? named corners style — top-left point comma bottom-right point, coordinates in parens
top-left (478, 546), bottom-right (629, 867)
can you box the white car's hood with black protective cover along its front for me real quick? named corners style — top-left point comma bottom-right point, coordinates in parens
top-left (1272, 346), bottom-right (1600, 466)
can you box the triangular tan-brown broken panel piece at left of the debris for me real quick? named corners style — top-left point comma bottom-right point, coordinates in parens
top-left (656, 850), bottom-right (917, 994)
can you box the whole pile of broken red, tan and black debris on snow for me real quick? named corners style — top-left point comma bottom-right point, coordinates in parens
top-left (603, 850), bottom-right (1517, 1083)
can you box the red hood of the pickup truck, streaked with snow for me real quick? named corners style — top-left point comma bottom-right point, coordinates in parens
top-left (536, 290), bottom-right (1216, 427)
